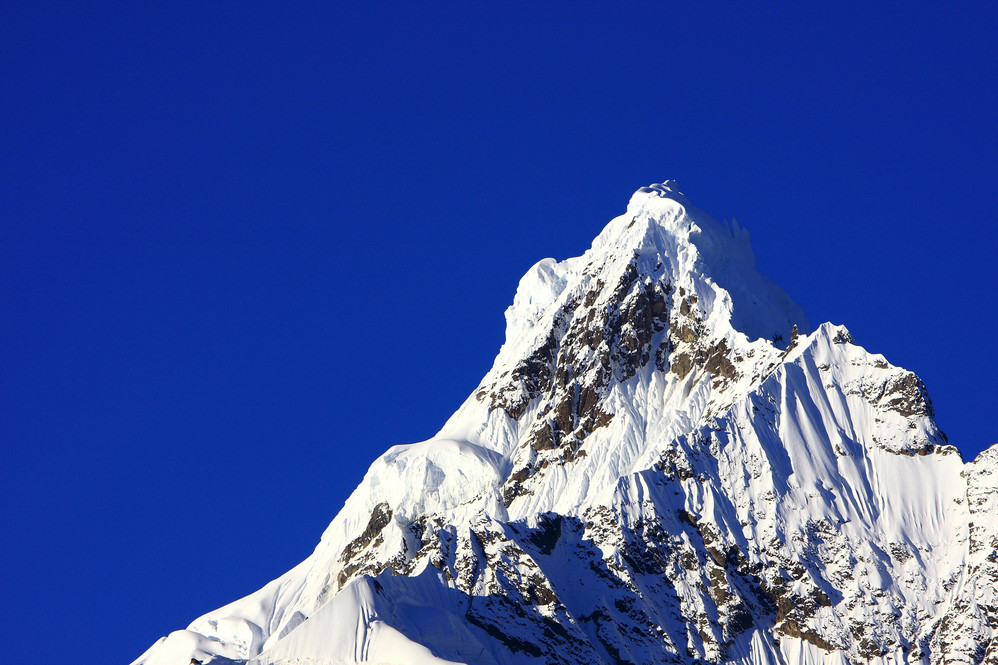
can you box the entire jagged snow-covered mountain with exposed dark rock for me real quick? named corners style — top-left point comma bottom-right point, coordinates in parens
top-left (135, 181), bottom-right (998, 665)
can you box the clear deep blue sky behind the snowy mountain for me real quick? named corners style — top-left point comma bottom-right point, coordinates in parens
top-left (0, 2), bottom-right (998, 663)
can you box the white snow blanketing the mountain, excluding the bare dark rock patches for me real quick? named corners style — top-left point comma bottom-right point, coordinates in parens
top-left (135, 181), bottom-right (998, 665)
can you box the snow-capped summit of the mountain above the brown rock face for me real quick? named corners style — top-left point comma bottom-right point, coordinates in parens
top-left (500, 180), bottom-right (811, 364)
